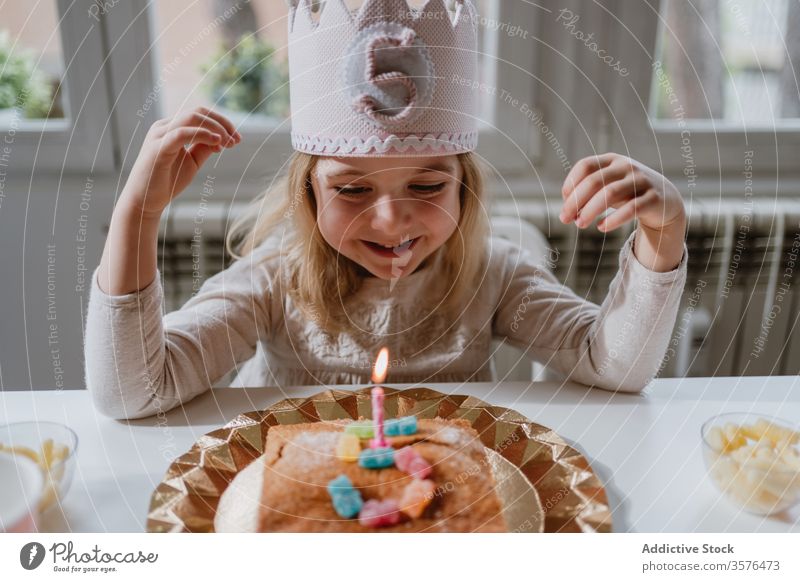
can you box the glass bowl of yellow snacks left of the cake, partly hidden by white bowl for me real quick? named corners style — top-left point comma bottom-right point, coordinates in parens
top-left (0, 421), bottom-right (78, 513)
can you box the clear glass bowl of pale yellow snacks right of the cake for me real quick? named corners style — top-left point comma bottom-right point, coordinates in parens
top-left (700, 412), bottom-right (800, 515)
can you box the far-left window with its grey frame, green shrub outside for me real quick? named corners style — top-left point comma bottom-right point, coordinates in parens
top-left (0, 0), bottom-right (114, 172)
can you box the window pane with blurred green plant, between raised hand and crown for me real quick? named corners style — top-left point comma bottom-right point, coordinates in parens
top-left (154, 0), bottom-right (289, 125)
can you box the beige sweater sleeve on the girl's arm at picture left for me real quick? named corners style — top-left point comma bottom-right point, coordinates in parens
top-left (85, 255), bottom-right (273, 419)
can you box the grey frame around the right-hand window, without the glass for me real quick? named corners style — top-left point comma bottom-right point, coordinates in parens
top-left (606, 0), bottom-right (800, 182)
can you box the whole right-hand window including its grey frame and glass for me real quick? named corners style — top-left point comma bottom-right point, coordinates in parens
top-left (608, 0), bottom-right (800, 178)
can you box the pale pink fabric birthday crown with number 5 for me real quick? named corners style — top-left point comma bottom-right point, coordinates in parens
top-left (289, 0), bottom-right (478, 157)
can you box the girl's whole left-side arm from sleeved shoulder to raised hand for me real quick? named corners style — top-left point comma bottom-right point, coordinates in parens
top-left (85, 110), bottom-right (271, 418)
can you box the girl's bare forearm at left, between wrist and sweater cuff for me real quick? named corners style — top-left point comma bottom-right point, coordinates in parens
top-left (97, 197), bottom-right (160, 295)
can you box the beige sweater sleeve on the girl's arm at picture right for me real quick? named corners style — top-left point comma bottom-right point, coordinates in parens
top-left (493, 232), bottom-right (687, 392)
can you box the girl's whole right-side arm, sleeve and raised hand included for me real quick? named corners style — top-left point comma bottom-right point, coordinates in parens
top-left (494, 154), bottom-right (686, 392)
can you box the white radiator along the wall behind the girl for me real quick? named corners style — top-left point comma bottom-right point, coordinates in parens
top-left (158, 200), bottom-right (800, 379)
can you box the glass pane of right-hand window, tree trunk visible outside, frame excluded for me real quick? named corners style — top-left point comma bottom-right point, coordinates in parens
top-left (651, 0), bottom-right (800, 126)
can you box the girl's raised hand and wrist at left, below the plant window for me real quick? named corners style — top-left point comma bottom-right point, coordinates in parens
top-left (120, 107), bottom-right (242, 217)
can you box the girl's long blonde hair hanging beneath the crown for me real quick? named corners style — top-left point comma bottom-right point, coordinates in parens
top-left (225, 152), bottom-right (489, 334)
